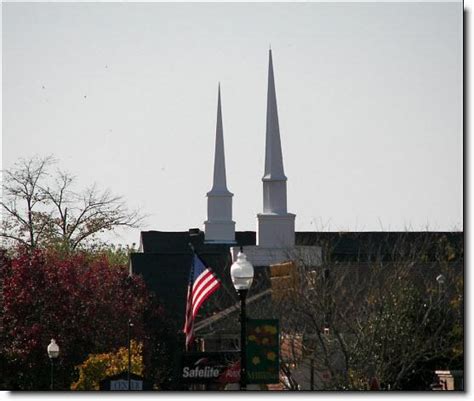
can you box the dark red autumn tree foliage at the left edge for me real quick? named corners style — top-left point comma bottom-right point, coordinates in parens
top-left (1, 245), bottom-right (159, 390)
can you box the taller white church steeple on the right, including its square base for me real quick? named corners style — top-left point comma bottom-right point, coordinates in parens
top-left (257, 49), bottom-right (295, 248)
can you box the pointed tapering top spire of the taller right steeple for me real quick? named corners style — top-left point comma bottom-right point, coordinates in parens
top-left (264, 49), bottom-right (286, 180)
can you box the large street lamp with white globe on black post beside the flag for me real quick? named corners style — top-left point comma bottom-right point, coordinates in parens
top-left (230, 247), bottom-right (253, 390)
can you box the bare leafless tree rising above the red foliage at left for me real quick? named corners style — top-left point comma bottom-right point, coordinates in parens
top-left (0, 156), bottom-right (143, 250)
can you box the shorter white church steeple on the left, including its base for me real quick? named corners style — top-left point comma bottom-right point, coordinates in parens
top-left (204, 84), bottom-right (235, 243)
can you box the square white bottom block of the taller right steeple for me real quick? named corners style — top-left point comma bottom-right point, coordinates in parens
top-left (257, 213), bottom-right (296, 248)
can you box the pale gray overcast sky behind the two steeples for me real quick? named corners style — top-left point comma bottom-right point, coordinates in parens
top-left (2, 3), bottom-right (463, 243)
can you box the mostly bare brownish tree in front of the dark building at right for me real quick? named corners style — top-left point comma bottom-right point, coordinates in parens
top-left (274, 234), bottom-right (463, 389)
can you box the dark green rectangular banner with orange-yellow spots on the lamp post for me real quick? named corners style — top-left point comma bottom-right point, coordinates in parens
top-left (247, 319), bottom-right (280, 384)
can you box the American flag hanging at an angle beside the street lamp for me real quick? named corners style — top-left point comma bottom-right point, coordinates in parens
top-left (183, 254), bottom-right (221, 350)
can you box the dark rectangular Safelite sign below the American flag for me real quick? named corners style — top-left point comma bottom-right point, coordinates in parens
top-left (180, 351), bottom-right (240, 383)
